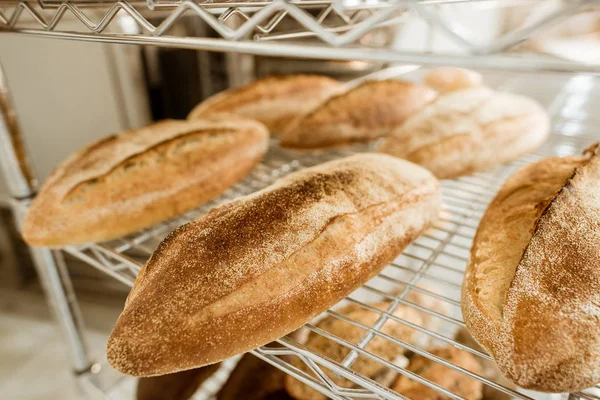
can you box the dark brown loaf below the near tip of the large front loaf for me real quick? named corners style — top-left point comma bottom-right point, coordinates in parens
top-left (136, 363), bottom-right (220, 400)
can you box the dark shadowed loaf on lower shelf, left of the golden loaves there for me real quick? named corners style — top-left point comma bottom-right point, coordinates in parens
top-left (217, 344), bottom-right (294, 400)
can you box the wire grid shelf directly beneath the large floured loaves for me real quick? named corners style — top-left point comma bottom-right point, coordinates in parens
top-left (59, 75), bottom-right (600, 399)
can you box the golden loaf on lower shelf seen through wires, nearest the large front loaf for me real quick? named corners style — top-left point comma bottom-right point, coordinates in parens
top-left (285, 303), bottom-right (422, 400)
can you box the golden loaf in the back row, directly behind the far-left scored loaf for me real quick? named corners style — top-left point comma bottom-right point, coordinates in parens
top-left (188, 75), bottom-right (343, 132)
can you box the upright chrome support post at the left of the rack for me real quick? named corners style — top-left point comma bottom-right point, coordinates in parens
top-left (0, 63), bottom-right (91, 373)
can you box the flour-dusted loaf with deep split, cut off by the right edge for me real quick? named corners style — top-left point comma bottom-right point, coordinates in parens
top-left (462, 145), bottom-right (600, 392)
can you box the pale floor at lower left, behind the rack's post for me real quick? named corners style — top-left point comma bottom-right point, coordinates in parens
top-left (0, 289), bottom-right (123, 400)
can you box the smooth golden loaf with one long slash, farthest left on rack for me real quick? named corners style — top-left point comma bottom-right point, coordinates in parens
top-left (23, 117), bottom-right (268, 247)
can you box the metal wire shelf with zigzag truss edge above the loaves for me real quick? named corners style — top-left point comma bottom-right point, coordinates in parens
top-left (0, 0), bottom-right (600, 74)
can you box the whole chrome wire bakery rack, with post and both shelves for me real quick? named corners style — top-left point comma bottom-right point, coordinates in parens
top-left (0, 0), bottom-right (600, 399)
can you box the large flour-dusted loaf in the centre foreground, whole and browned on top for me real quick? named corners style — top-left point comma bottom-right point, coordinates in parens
top-left (108, 153), bottom-right (439, 376)
